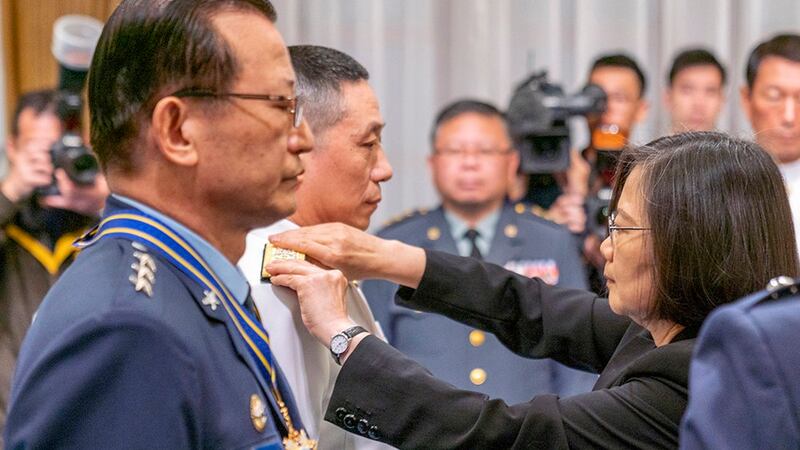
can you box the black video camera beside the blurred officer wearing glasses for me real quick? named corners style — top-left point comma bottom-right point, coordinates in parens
top-left (507, 71), bottom-right (607, 174)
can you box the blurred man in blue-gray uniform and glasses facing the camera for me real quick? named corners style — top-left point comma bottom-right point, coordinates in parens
top-left (364, 100), bottom-right (597, 404)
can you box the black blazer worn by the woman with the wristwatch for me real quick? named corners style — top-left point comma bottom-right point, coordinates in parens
top-left (325, 251), bottom-right (697, 449)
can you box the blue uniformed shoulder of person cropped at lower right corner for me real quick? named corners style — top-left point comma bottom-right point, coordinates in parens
top-left (680, 277), bottom-right (800, 449)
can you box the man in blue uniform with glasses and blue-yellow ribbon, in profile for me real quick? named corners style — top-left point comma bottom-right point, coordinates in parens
top-left (6, 0), bottom-right (316, 449)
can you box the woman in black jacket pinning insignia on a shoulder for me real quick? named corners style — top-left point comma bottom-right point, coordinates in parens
top-left (268, 133), bottom-right (798, 449)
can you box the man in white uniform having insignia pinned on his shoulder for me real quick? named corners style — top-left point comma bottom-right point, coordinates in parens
top-left (239, 46), bottom-right (392, 449)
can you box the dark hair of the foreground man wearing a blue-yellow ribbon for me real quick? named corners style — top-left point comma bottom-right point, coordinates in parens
top-left (88, 0), bottom-right (276, 172)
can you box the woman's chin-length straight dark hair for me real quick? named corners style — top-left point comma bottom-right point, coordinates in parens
top-left (611, 132), bottom-right (798, 327)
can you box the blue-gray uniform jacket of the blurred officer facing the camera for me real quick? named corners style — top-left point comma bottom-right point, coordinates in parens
top-left (362, 204), bottom-right (597, 404)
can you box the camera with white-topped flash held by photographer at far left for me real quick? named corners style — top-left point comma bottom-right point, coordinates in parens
top-left (40, 15), bottom-right (103, 195)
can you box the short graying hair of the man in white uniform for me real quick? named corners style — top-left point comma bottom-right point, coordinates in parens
top-left (289, 45), bottom-right (369, 133)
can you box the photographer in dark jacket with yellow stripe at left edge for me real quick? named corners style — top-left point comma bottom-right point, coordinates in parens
top-left (0, 90), bottom-right (108, 436)
